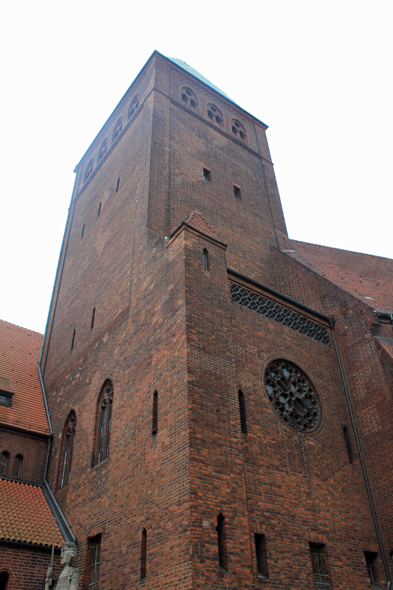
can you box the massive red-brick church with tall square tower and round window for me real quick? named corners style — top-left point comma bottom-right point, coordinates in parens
top-left (0, 52), bottom-right (393, 590)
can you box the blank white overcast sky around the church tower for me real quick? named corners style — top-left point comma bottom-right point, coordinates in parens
top-left (0, 0), bottom-right (393, 332)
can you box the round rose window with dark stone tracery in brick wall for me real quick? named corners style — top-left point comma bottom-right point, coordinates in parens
top-left (265, 359), bottom-right (321, 432)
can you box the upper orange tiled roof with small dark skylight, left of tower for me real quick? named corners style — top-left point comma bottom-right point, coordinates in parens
top-left (0, 320), bottom-right (50, 434)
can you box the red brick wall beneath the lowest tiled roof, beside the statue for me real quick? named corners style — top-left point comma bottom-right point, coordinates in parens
top-left (0, 545), bottom-right (61, 590)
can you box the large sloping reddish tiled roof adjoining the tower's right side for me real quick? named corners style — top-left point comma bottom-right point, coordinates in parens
top-left (291, 240), bottom-right (393, 312)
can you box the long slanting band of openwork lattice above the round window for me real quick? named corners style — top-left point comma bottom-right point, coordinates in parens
top-left (231, 283), bottom-right (330, 344)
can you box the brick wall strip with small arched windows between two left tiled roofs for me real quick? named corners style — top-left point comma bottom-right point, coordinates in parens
top-left (0, 428), bottom-right (48, 484)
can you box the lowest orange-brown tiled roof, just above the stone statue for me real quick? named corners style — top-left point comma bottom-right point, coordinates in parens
top-left (0, 479), bottom-right (64, 547)
